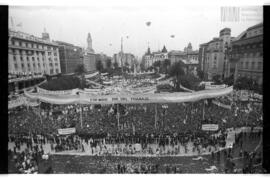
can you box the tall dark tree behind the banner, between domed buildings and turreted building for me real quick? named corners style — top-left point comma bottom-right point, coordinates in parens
top-left (169, 61), bottom-right (185, 91)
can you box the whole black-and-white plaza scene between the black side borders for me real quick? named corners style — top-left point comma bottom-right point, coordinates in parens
top-left (3, 1), bottom-right (266, 174)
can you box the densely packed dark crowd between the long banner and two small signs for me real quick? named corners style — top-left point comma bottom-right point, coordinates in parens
top-left (9, 92), bottom-right (262, 135)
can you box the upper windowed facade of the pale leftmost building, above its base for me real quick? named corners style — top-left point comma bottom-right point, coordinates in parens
top-left (8, 30), bottom-right (61, 75)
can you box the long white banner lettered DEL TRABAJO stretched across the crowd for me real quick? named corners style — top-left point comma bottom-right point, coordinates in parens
top-left (25, 87), bottom-right (233, 104)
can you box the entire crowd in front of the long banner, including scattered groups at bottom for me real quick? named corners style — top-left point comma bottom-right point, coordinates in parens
top-left (8, 84), bottom-right (263, 173)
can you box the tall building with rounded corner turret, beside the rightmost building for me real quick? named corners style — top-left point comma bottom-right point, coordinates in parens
top-left (199, 28), bottom-right (233, 80)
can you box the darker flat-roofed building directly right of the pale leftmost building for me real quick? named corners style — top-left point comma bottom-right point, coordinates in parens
top-left (55, 41), bottom-right (83, 74)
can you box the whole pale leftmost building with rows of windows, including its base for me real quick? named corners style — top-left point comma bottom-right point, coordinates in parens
top-left (8, 29), bottom-right (61, 92)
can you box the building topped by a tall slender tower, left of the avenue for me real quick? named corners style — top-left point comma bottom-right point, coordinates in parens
top-left (83, 33), bottom-right (96, 71)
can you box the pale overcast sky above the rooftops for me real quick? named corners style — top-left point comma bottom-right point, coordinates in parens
top-left (9, 4), bottom-right (262, 58)
